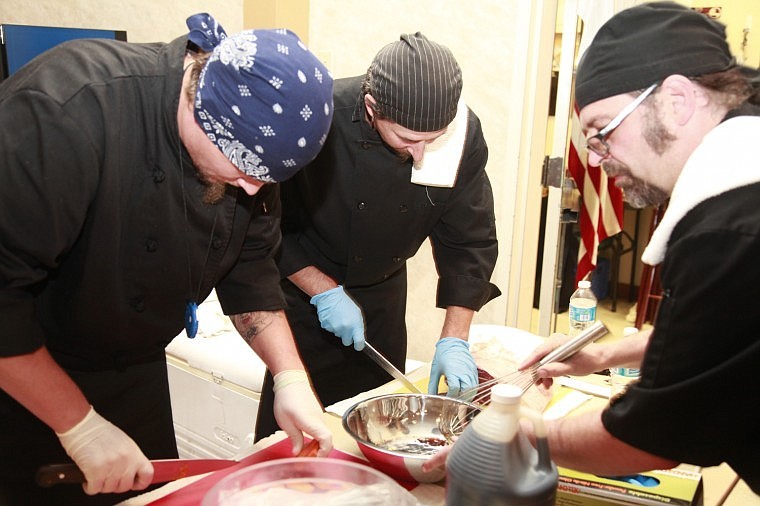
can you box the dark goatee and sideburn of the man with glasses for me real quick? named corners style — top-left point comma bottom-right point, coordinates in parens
top-left (602, 105), bottom-right (676, 208)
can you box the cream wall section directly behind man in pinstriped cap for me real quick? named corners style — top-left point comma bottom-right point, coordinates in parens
top-left (309, 0), bottom-right (521, 360)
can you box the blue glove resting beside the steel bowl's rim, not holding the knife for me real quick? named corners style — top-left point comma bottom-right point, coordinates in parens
top-left (428, 337), bottom-right (478, 397)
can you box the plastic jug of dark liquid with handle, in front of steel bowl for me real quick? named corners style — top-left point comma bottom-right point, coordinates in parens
top-left (446, 383), bottom-right (558, 506)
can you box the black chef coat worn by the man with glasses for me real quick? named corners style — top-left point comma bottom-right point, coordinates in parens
top-left (602, 184), bottom-right (760, 493)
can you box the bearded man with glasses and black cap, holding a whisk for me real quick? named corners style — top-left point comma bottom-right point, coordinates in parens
top-left (429, 2), bottom-right (760, 493)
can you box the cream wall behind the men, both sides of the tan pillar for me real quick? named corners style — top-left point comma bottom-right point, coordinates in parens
top-left (0, 0), bottom-right (548, 360)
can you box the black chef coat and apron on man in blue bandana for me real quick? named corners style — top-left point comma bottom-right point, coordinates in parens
top-left (0, 37), bottom-right (284, 504)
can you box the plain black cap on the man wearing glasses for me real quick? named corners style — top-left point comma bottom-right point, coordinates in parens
top-left (575, 2), bottom-right (736, 109)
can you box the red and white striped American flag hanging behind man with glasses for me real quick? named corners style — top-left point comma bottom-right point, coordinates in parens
top-left (567, 108), bottom-right (623, 286)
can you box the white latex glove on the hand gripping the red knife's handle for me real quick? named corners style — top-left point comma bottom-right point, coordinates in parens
top-left (56, 406), bottom-right (153, 495)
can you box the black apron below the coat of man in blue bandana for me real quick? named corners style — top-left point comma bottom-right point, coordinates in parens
top-left (0, 359), bottom-right (178, 506)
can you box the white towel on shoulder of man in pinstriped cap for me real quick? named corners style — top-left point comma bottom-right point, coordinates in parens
top-left (411, 100), bottom-right (467, 188)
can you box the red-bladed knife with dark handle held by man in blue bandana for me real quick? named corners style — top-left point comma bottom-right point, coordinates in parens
top-left (35, 459), bottom-right (238, 487)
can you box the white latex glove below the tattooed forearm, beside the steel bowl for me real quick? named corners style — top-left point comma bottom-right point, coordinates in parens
top-left (273, 369), bottom-right (332, 457)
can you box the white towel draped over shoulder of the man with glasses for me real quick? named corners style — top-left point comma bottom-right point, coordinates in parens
top-left (641, 116), bottom-right (760, 265)
